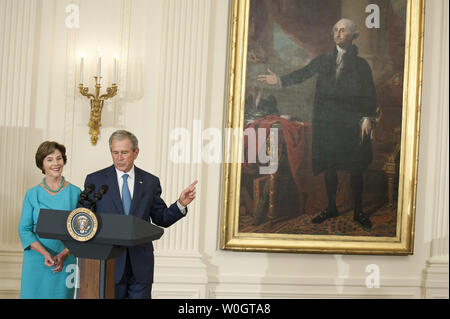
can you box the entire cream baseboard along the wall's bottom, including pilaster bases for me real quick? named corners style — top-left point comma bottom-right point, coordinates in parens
top-left (0, 250), bottom-right (449, 299)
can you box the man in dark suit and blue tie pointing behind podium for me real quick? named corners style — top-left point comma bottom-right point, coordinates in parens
top-left (84, 130), bottom-right (197, 299)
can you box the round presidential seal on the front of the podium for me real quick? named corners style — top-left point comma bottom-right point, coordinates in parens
top-left (67, 207), bottom-right (98, 241)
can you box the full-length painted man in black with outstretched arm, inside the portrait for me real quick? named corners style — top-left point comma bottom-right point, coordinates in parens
top-left (258, 19), bottom-right (376, 229)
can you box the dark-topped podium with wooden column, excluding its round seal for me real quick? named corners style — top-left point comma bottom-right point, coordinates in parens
top-left (36, 209), bottom-right (164, 299)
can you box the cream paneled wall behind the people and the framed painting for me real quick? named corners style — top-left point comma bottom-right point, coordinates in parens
top-left (0, 0), bottom-right (448, 298)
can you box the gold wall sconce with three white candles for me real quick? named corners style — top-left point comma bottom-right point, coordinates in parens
top-left (78, 49), bottom-right (119, 145)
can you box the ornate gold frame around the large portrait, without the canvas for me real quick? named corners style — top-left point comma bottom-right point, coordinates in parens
top-left (220, 0), bottom-right (425, 255)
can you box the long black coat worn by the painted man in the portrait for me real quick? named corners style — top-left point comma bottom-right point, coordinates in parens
top-left (281, 46), bottom-right (376, 175)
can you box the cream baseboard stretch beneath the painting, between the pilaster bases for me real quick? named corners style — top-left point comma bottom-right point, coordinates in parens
top-left (207, 275), bottom-right (422, 299)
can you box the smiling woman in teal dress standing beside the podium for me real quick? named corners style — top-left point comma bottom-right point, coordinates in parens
top-left (19, 141), bottom-right (81, 299)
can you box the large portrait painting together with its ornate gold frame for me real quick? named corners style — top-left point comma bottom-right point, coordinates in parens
top-left (221, 0), bottom-right (425, 255)
